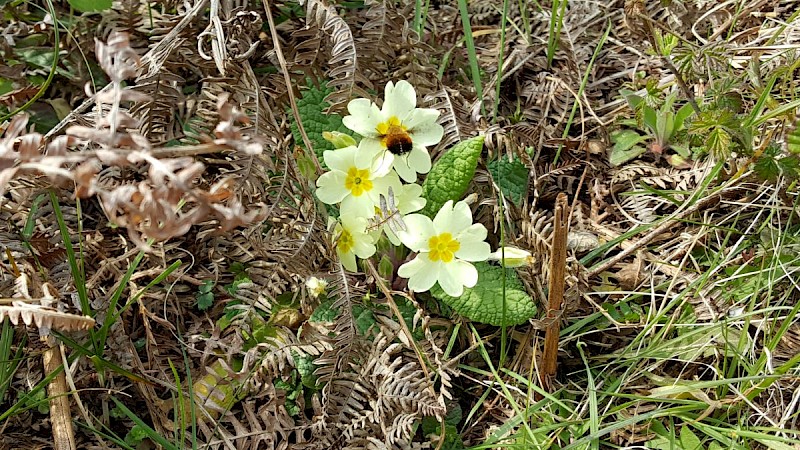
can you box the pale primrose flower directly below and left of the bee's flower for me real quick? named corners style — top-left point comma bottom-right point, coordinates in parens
top-left (317, 146), bottom-right (400, 218)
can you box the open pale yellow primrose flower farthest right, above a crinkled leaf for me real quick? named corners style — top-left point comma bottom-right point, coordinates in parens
top-left (397, 200), bottom-right (491, 297)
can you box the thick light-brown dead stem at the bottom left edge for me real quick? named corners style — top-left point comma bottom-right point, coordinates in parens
top-left (42, 344), bottom-right (78, 450)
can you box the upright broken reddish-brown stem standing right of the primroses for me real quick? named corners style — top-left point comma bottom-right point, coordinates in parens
top-left (539, 192), bottom-right (569, 391)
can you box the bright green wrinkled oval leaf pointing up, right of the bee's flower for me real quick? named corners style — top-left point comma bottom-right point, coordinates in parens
top-left (421, 136), bottom-right (483, 217)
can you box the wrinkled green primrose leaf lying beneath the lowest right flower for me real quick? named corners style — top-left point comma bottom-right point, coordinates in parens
top-left (431, 262), bottom-right (536, 326)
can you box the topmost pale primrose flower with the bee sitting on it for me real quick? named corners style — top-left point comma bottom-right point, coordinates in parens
top-left (342, 81), bottom-right (444, 183)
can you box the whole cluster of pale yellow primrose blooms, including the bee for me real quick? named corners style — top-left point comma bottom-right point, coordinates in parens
top-left (317, 81), bottom-right (528, 297)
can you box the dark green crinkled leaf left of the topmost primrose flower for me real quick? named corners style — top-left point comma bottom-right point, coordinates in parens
top-left (288, 83), bottom-right (352, 167)
